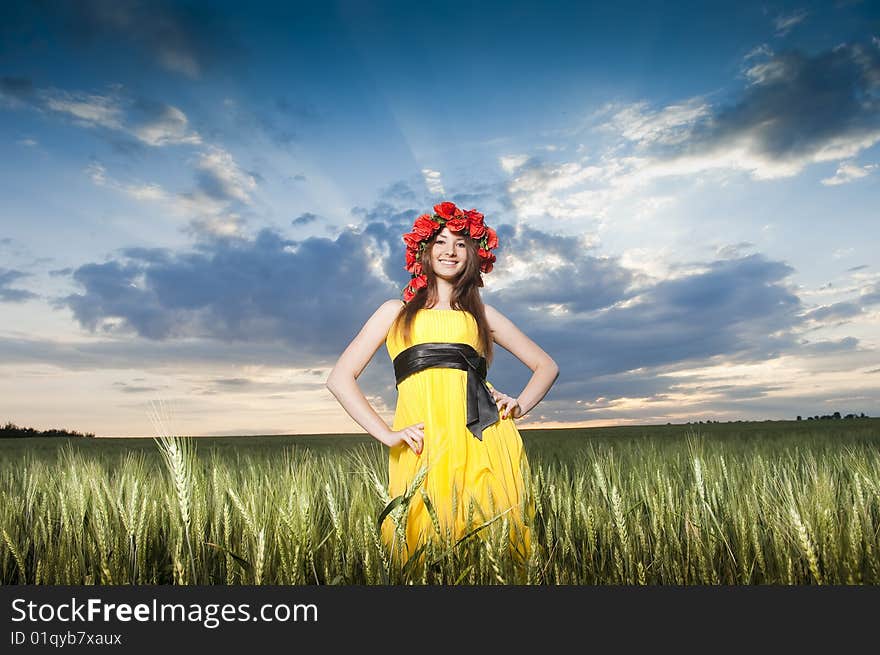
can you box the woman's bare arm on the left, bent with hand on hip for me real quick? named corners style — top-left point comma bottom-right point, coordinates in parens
top-left (326, 300), bottom-right (402, 445)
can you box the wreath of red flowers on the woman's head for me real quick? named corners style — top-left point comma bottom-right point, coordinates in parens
top-left (403, 202), bottom-right (498, 302)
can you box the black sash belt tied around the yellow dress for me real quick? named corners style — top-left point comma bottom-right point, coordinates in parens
top-left (394, 342), bottom-right (498, 441)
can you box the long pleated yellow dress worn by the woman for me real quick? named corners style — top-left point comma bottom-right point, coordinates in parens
top-left (382, 309), bottom-right (534, 563)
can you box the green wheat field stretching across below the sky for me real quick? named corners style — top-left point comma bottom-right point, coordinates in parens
top-left (0, 418), bottom-right (880, 585)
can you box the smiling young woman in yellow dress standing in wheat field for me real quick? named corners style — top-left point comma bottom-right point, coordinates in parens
top-left (327, 202), bottom-right (559, 561)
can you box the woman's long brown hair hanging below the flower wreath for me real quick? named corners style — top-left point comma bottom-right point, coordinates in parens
top-left (391, 232), bottom-right (493, 366)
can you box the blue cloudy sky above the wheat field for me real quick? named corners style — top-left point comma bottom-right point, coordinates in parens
top-left (0, 0), bottom-right (880, 436)
